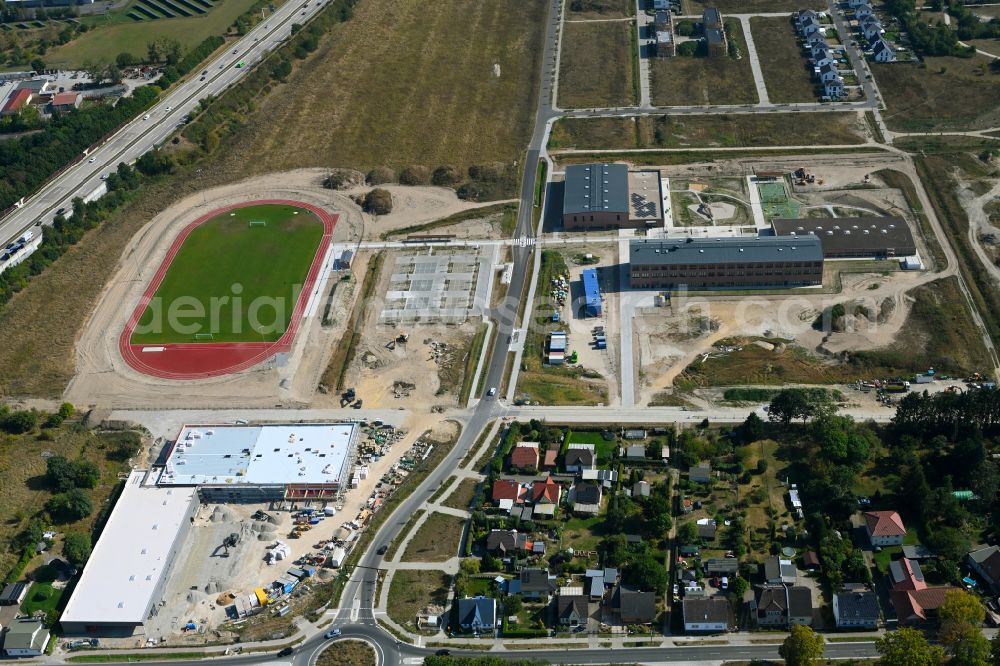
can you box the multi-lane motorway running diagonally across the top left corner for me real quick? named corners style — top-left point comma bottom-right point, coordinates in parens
top-left (0, 0), bottom-right (327, 246)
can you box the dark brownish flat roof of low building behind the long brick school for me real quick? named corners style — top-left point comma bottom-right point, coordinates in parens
top-left (771, 217), bottom-right (916, 254)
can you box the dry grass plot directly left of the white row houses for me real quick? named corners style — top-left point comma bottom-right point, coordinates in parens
top-left (750, 16), bottom-right (817, 103)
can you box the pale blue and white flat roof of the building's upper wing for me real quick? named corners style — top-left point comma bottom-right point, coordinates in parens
top-left (159, 423), bottom-right (358, 485)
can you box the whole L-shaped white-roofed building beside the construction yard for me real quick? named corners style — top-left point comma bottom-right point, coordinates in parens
top-left (60, 423), bottom-right (361, 635)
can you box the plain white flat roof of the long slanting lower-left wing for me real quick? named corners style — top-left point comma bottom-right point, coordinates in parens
top-left (61, 470), bottom-right (197, 625)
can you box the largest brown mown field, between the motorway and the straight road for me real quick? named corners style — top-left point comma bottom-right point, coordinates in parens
top-left (216, 0), bottom-right (547, 173)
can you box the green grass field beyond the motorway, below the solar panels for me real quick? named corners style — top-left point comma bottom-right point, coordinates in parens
top-left (45, 0), bottom-right (262, 67)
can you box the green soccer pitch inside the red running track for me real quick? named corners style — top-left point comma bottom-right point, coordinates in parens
top-left (131, 205), bottom-right (323, 345)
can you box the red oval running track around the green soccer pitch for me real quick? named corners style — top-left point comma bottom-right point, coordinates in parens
top-left (118, 199), bottom-right (339, 379)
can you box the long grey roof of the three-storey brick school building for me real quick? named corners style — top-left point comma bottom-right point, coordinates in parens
top-left (629, 235), bottom-right (823, 266)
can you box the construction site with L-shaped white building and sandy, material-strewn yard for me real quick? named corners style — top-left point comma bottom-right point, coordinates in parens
top-left (64, 423), bottom-right (464, 647)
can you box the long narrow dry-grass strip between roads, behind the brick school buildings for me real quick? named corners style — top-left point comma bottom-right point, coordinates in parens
top-left (549, 112), bottom-right (865, 150)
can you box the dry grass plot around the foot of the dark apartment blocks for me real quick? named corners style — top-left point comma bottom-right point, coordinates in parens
top-left (649, 20), bottom-right (759, 106)
